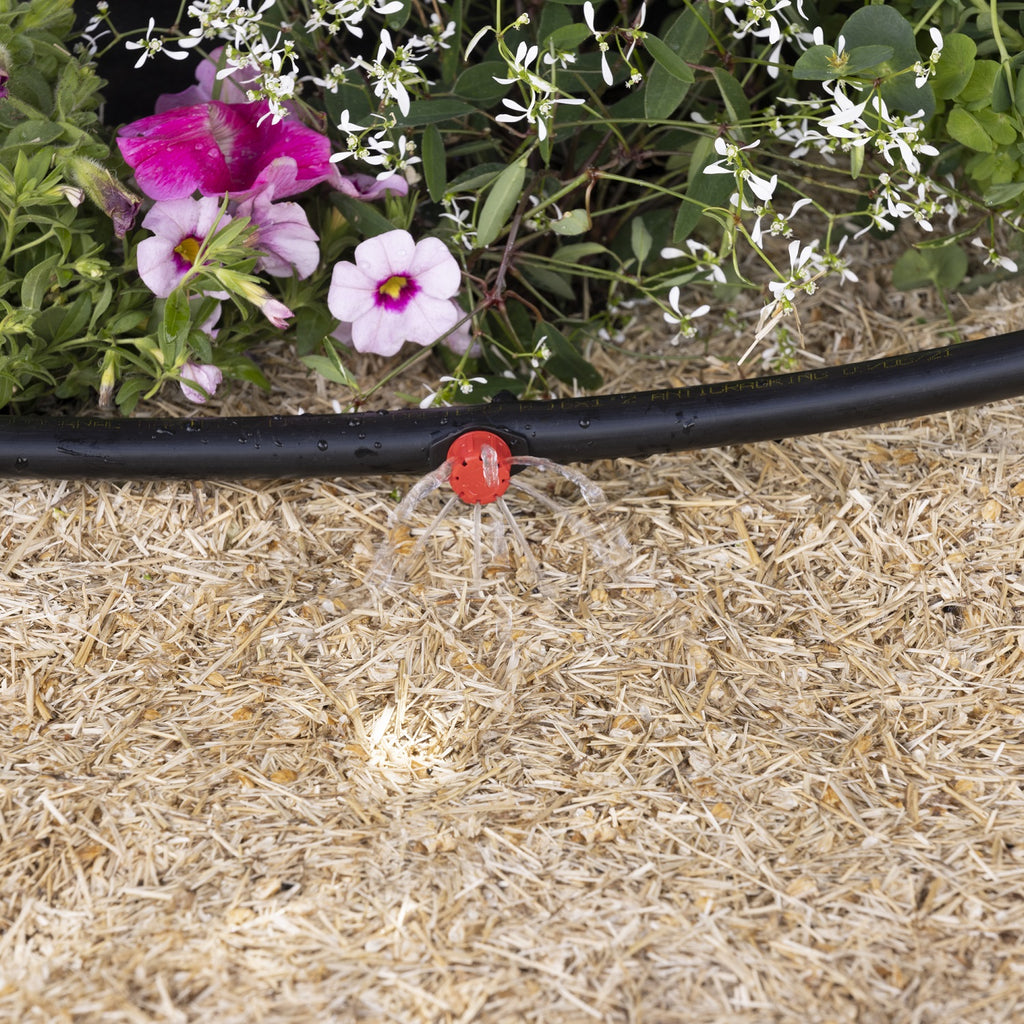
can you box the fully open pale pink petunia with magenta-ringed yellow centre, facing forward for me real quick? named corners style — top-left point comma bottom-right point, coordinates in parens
top-left (327, 230), bottom-right (462, 355)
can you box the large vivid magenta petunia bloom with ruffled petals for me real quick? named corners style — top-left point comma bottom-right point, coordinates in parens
top-left (118, 100), bottom-right (341, 200)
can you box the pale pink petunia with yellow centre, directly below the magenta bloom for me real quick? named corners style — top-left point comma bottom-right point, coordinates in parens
top-left (135, 196), bottom-right (231, 298)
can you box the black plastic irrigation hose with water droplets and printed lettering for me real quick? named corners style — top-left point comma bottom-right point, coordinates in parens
top-left (0, 331), bottom-right (1024, 479)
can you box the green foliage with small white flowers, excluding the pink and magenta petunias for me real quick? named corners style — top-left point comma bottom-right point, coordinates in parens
top-left (6, 0), bottom-right (1024, 412)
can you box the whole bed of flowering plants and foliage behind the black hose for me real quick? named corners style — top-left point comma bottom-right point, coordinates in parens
top-left (0, 0), bottom-right (1024, 413)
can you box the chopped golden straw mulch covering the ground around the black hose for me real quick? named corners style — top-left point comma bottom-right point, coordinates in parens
top-left (0, 253), bottom-right (1024, 1024)
